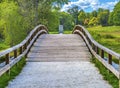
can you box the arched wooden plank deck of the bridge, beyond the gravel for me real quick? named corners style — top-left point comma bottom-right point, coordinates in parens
top-left (27, 34), bottom-right (91, 62)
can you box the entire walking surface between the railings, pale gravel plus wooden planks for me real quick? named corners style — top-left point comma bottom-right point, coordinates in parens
top-left (8, 34), bottom-right (111, 88)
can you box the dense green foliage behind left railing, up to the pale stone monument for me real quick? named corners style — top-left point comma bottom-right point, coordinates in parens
top-left (0, 0), bottom-right (68, 46)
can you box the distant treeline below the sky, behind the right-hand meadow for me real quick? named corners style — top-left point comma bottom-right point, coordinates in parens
top-left (64, 2), bottom-right (120, 26)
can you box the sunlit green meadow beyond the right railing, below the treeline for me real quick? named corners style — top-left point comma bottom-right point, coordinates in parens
top-left (86, 26), bottom-right (120, 53)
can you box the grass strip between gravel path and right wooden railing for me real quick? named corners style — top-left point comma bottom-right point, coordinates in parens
top-left (92, 58), bottom-right (119, 88)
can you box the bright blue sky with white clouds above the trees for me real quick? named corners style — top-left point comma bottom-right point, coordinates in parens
top-left (61, 0), bottom-right (120, 12)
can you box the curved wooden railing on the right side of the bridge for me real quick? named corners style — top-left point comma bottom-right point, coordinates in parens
top-left (73, 25), bottom-right (120, 79)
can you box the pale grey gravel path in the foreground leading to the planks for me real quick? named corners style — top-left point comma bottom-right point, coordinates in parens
top-left (7, 61), bottom-right (112, 88)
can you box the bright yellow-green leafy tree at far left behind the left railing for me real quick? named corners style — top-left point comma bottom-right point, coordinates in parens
top-left (0, 1), bottom-right (26, 46)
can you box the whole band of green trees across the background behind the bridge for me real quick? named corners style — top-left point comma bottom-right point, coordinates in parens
top-left (0, 0), bottom-right (120, 46)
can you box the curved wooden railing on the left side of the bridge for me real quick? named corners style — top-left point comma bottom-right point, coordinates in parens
top-left (0, 25), bottom-right (48, 76)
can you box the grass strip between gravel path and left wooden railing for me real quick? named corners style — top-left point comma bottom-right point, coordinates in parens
top-left (0, 57), bottom-right (26, 88)
